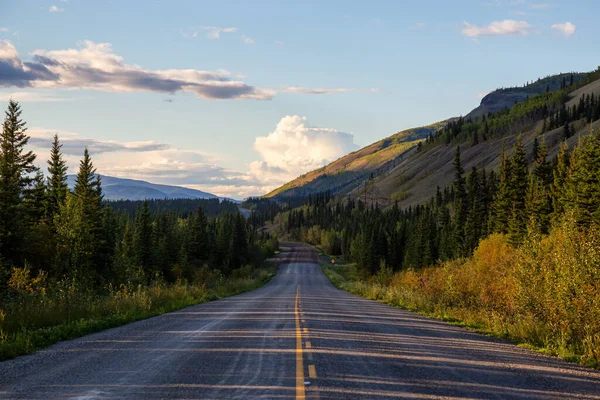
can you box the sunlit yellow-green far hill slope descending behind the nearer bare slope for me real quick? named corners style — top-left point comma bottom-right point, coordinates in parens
top-left (265, 121), bottom-right (445, 197)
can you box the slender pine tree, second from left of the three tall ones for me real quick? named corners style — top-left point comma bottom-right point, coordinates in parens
top-left (46, 135), bottom-right (69, 222)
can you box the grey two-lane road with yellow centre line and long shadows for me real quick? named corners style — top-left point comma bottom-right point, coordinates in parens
top-left (0, 245), bottom-right (600, 399)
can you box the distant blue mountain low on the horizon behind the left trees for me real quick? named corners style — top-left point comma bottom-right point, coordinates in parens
top-left (67, 175), bottom-right (217, 200)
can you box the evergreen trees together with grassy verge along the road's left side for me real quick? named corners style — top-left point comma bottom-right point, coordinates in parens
top-left (0, 101), bottom-right (278, 359)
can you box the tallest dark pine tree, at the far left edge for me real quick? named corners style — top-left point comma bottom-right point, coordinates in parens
top-left (0, 100), bottom-right (36, 275)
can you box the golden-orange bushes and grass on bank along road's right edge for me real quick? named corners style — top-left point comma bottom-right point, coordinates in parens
top-left (323, 219), bottom-right (600, 368)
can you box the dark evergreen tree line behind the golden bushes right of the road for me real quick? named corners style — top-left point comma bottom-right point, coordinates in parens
top-left (275, 125), bottom-right (600, 274)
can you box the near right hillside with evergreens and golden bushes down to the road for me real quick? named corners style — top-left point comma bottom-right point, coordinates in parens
top-left (273, 66), bottom-right (600, 365)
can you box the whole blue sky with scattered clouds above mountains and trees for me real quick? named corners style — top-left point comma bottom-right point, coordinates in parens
top-left (0, 0), bottom-right (600, 199)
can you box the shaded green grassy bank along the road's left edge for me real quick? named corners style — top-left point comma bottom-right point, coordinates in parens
top-left (0, 264), bottom-right (276, 360)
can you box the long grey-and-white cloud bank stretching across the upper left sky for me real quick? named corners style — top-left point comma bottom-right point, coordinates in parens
top-left (0, 40), bottom-right (276, 100)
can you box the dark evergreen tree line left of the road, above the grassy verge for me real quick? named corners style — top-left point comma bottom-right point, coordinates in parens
top-left (0, 100), bottom-right (277, 293)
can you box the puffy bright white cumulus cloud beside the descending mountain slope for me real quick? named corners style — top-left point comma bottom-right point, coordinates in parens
top-left (250, 115), bottom-right (357, 189)
